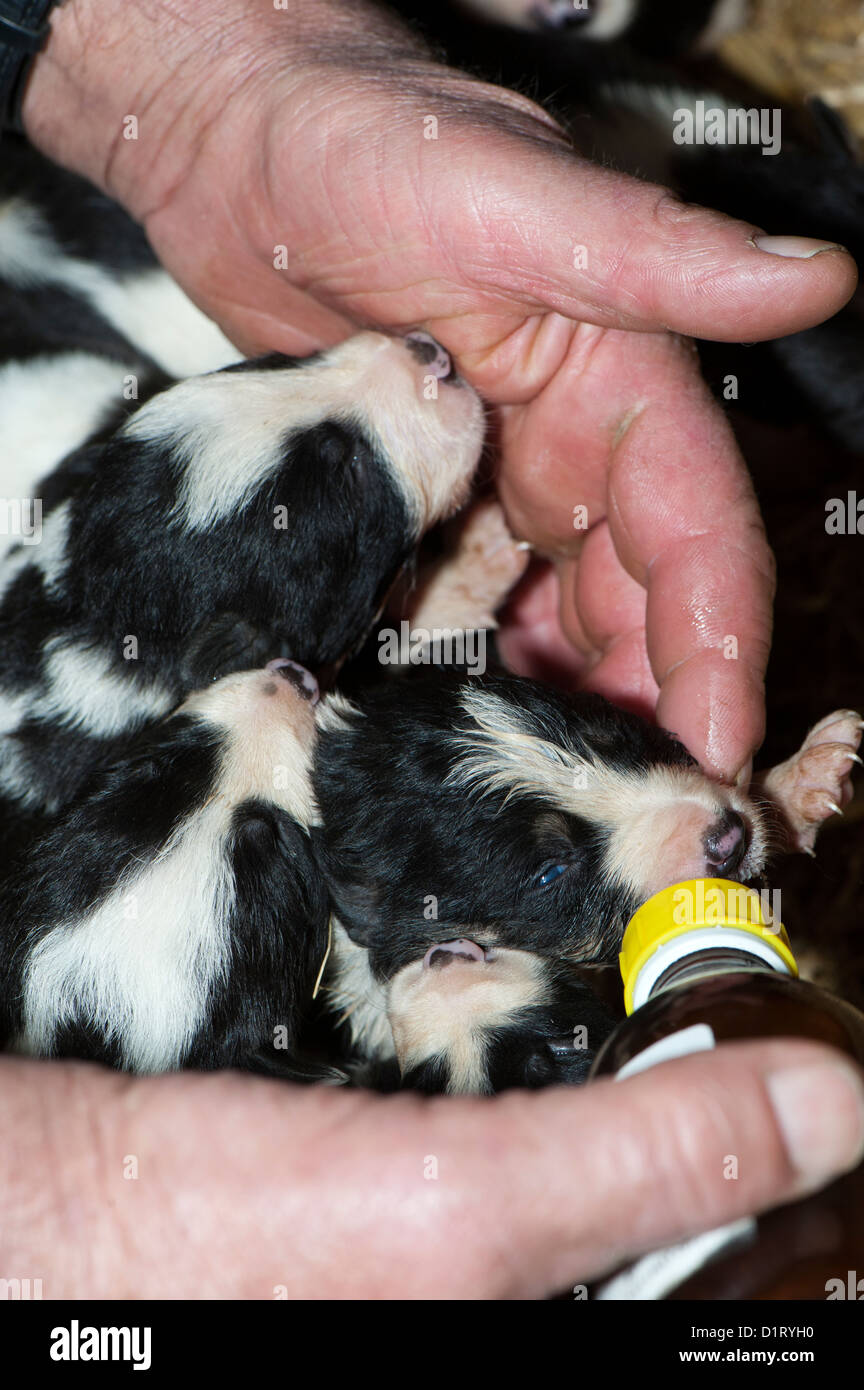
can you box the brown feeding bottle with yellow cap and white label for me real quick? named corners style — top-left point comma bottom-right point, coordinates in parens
top-left (592, 878), bottom-right (864, 1300)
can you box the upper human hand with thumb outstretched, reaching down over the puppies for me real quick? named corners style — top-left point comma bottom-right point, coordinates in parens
top-left (24, 0), bottom-right (856, 778)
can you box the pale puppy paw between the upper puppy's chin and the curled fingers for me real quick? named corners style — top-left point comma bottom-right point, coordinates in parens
top-left (408, 498), bottom-right (529, 631)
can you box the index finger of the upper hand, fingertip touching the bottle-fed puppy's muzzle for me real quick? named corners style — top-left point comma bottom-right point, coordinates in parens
top-left (608, 358), bottom-right (774, 780)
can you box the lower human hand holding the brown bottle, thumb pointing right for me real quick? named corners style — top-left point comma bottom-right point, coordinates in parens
top-left (0, 1043), bottom-right (864, 1300)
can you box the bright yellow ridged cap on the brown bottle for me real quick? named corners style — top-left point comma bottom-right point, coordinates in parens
top-left (618, 878), bottom-right (797, 1013)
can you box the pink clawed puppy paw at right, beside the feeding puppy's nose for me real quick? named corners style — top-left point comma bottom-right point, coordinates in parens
top-left (757, 709), bottom-right (864, 855)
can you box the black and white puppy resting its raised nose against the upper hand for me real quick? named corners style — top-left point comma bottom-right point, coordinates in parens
top-left (0, 332), bottom-right (483, 808)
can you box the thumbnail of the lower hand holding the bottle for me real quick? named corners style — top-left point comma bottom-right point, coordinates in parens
top-left (765, 1061), bottom-right (864, 1191)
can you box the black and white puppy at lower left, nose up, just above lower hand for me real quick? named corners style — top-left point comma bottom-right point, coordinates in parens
top-left (0, 660), bottom-right (328, 1077)
